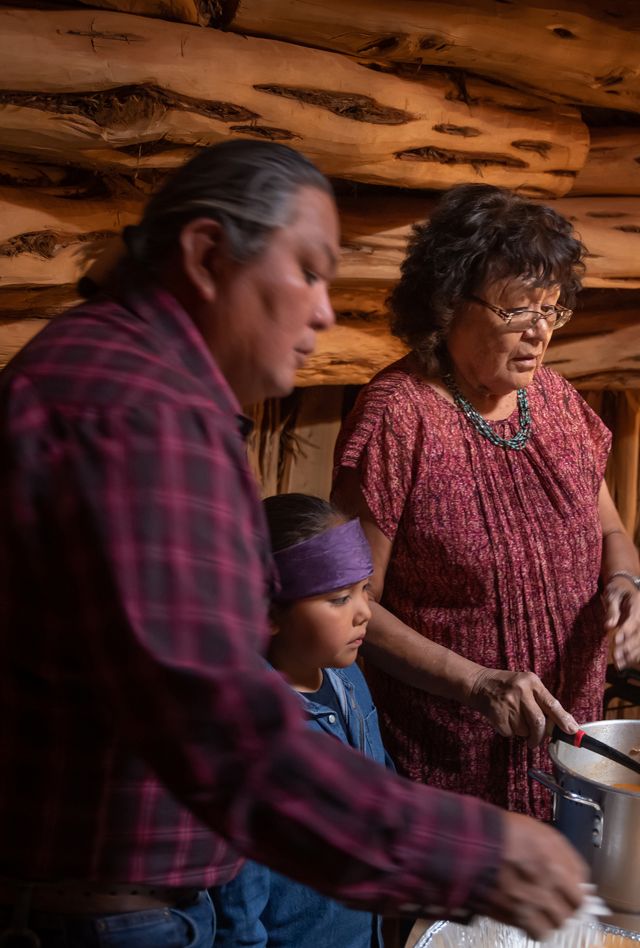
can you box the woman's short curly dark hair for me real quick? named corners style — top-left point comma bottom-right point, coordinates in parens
top-left (388, 184), bottom-right (586, 374)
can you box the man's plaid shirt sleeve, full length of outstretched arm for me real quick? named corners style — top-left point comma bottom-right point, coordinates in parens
top-left (7, 374), bottom-right (502, 917)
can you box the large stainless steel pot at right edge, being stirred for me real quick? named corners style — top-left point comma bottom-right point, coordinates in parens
top-left (529, 721), bottom-right (640, 912)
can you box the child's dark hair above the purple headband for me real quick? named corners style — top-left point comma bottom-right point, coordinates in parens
top-left (262, 494), bottom-right (347, 553)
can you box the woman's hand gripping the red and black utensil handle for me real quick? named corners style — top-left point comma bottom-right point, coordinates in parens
top-left (469, 668), bottom-right (579, 747)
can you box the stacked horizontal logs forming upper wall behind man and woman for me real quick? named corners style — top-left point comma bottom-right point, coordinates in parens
top-left (0, 0), bottom-right (640, 388)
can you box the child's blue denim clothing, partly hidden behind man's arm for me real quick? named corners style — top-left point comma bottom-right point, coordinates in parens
top-left (211, 664), bottom-right (393, 948)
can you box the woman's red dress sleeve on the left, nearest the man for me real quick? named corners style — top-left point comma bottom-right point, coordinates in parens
top-left (334, 376), bottom-right (420, 541)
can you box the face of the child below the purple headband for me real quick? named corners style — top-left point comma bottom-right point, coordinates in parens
top-left (269, 578), bottom-right (371, 691)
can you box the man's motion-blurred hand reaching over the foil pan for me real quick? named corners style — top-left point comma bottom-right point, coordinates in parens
top-left (483, 813), bottom-right (588, 940)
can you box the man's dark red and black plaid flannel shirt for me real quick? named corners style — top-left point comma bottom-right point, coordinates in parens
top-left (0, 287), bottom-right (501, 915)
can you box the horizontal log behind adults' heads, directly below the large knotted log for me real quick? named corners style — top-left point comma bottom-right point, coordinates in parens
top-left (0, 188), bottom-right (640, 304)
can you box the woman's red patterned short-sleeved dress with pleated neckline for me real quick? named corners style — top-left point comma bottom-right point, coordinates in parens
top-left (336, 355), bottom-right (611, 818)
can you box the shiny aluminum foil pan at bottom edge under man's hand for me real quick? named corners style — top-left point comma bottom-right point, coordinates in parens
top-left (415, 918), bottom-right (640, 948)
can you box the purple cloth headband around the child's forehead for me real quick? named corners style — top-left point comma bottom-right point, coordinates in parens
top-left (273, 520), bottom-right (373, 602)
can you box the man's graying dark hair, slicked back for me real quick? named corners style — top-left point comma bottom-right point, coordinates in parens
top-left (123, 139), bottom-right (333, 270)
